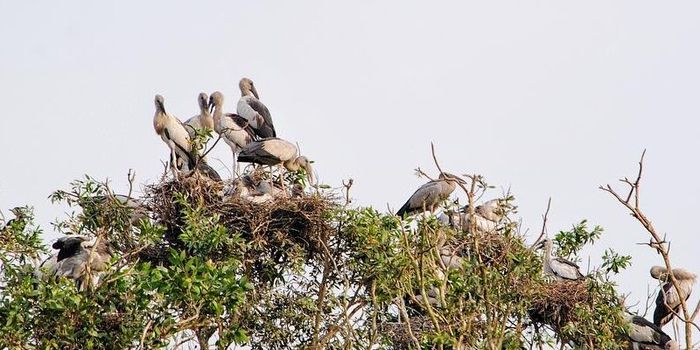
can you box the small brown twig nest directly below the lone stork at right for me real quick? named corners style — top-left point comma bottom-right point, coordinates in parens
top-left (529, 280), bottom-right (591, 331)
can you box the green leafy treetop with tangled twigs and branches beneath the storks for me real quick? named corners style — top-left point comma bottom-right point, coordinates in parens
top-left (0, 178), bottom-right (629, 350)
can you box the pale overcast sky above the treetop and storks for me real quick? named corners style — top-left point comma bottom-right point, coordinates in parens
top-left (0, 0), bottom-right (700, 344)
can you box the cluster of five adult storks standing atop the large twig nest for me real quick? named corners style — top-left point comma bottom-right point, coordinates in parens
top-left (153, 78), bottom-right (313, 184)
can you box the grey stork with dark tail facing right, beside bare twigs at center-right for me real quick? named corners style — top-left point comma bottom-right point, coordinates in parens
top-left (396, 173), bottom-right (466, 217)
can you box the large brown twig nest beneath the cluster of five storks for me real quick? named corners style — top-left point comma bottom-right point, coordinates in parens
top-left (141, 175), bottom-right (336, 278)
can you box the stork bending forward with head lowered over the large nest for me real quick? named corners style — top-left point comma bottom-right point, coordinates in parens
top-left (238, 137), bottom-right (314, 184)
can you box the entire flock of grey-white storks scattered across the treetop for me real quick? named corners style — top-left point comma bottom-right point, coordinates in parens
top-left (2, 78), bottom-right (697, 350)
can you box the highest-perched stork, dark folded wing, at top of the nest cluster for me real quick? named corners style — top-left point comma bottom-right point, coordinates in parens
top-left (236, 78), bottom-right (277, 138)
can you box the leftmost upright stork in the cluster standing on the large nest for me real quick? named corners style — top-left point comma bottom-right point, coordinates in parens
top-left (153, 95), bottom-right (196, 179)
